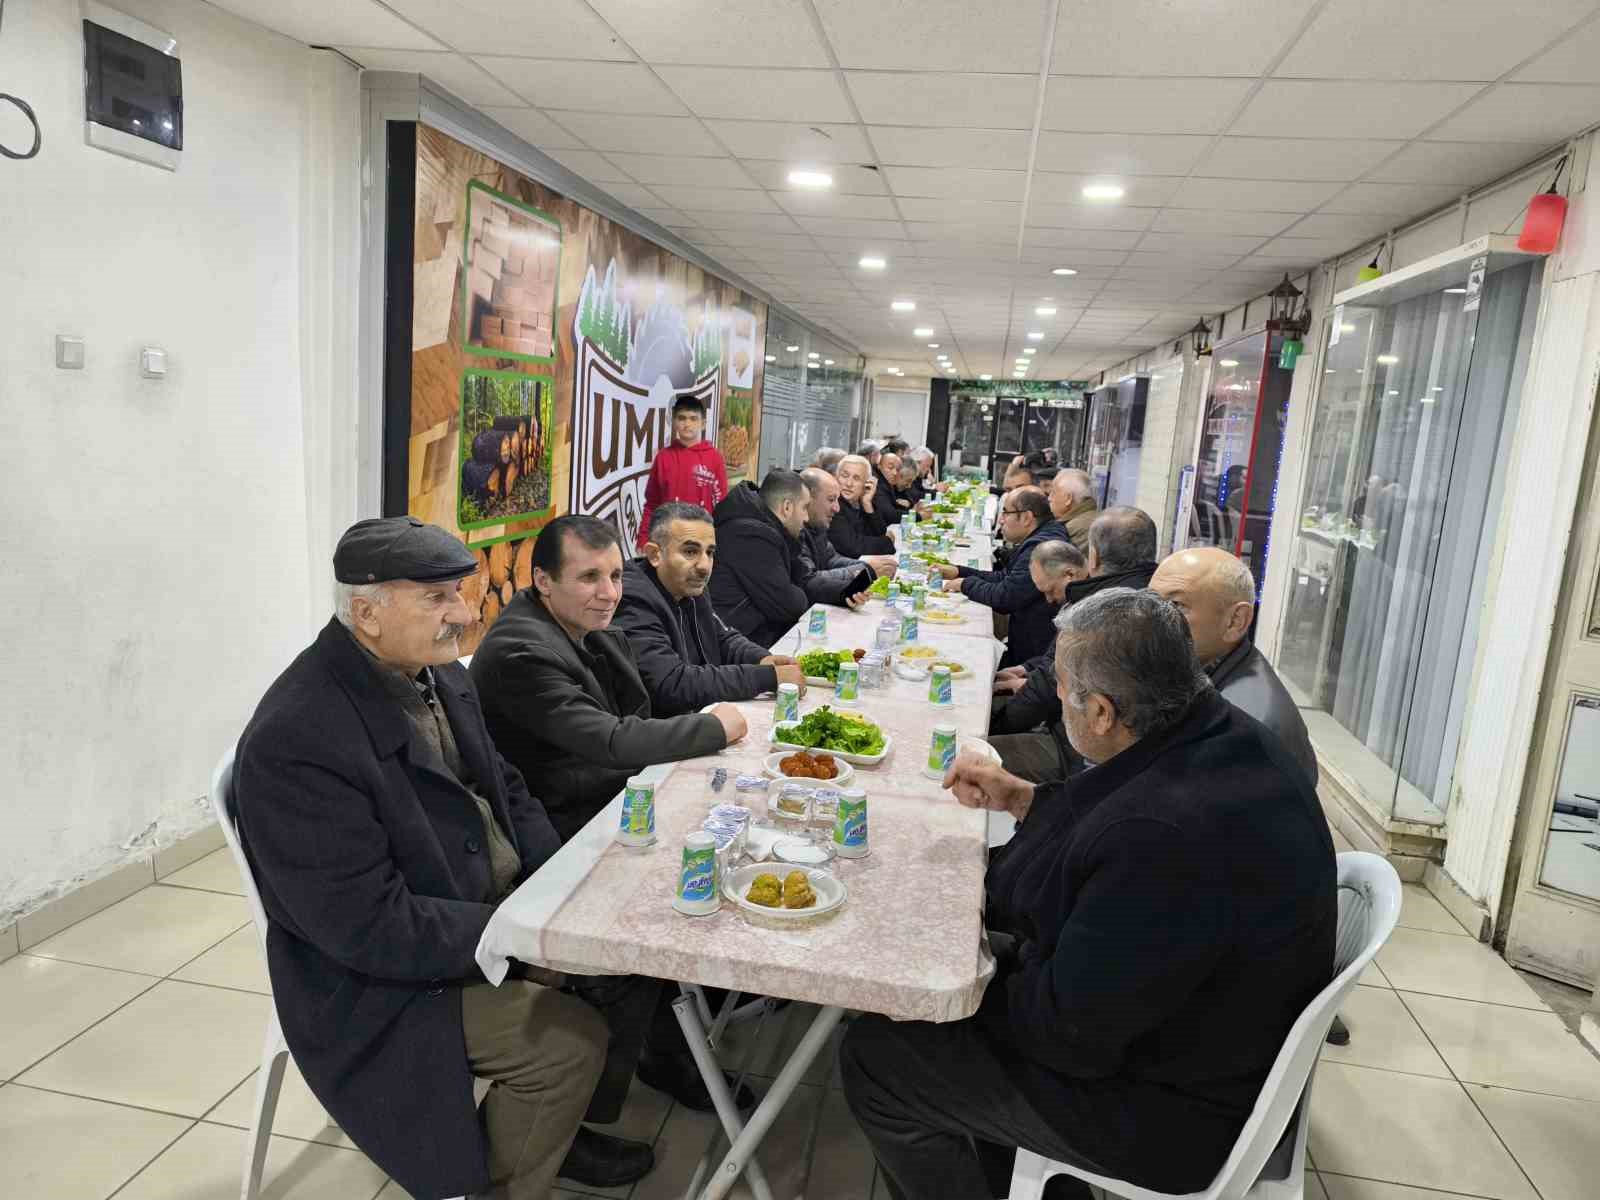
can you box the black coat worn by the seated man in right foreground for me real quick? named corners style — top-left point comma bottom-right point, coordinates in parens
top-left (978, 690), bottom-right (1338, 1192)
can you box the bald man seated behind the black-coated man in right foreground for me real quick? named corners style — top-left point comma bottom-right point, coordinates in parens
top-left (1150, 546), bottom-right (1317, 787)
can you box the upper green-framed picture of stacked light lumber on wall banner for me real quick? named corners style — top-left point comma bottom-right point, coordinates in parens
top-left (461, 181), bottom-right (562, 362)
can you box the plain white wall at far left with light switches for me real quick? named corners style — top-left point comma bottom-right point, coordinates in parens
top-left (0, 0), bottom-right (358, 925)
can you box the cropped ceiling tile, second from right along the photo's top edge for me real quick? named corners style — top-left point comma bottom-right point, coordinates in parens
top-left (1050, 0), bottom-right (1314, 75)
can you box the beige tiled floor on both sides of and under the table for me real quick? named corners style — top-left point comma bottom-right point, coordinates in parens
top-left (0, 851), bottom-right (1600, 1200)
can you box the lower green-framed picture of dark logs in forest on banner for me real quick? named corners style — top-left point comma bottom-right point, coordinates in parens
top-left (456, 371), bottom-right (554, 530)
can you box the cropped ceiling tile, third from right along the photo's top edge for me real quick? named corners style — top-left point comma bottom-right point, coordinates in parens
top-left (814, 0), bottom-right (1045, 74)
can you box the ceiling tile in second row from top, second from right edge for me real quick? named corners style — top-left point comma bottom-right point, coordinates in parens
top-left (1229, 80), bottom-right (1480, 139)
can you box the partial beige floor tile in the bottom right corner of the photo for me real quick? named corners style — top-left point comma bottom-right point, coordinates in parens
top-left (1467, 1083), bottom-right (1600, 1200)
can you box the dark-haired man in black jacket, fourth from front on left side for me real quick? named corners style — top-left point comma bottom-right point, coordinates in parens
top-left (710, 469), bottom-right (832, 646)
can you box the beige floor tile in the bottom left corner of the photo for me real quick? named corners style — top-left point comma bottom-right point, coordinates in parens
top-left (0, 1085), bottom-right (188, 1200)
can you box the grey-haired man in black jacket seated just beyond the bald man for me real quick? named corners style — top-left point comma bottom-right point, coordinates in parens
top-left (989, 504), bottom-right (1157, 784)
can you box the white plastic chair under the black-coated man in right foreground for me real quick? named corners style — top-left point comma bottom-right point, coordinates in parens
top-left (1011, 851), bottom-right (1402, 1200)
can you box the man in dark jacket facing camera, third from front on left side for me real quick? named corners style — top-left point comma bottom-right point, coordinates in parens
top-left (616, 504), bottom-right (805, 717)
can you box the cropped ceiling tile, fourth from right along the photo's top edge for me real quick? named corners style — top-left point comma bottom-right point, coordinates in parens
top-left (582, 0), bottom-right (829, 67)
